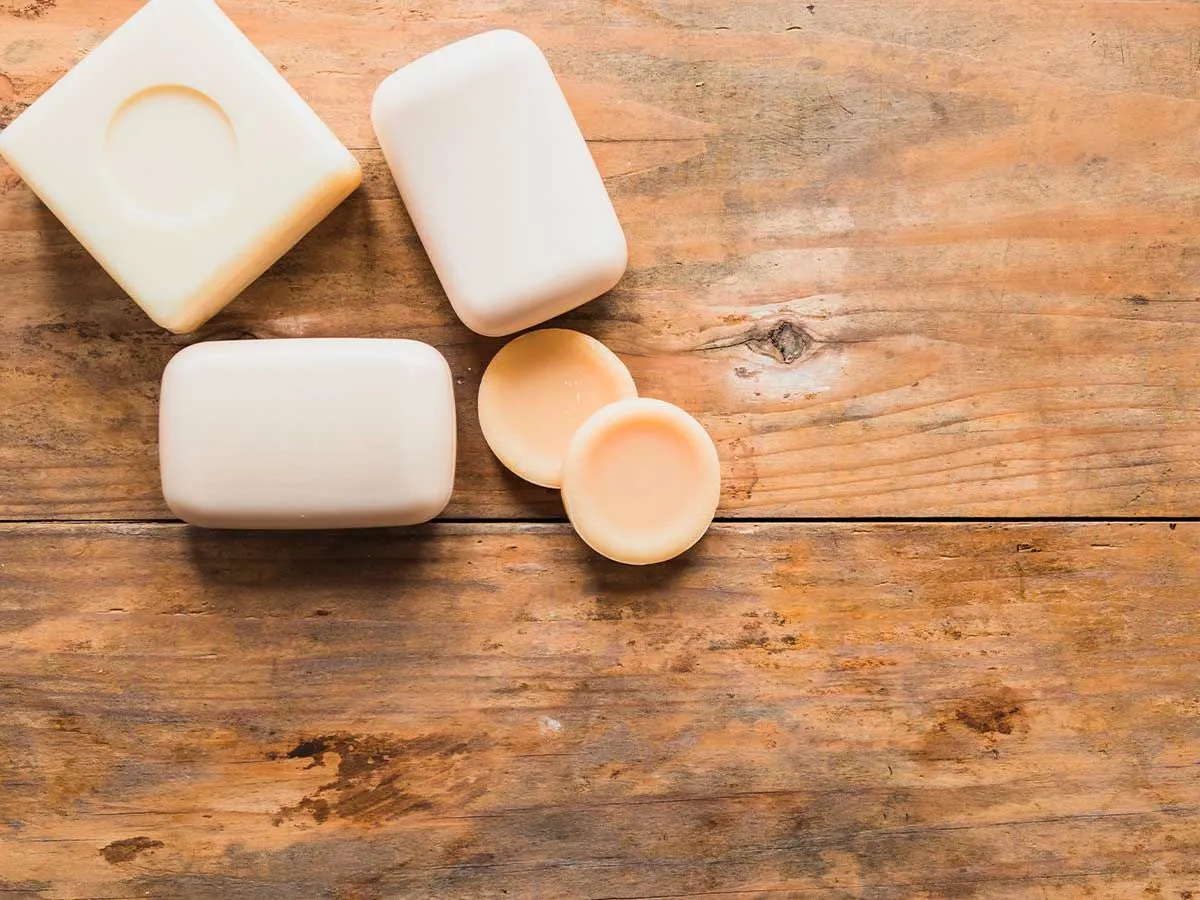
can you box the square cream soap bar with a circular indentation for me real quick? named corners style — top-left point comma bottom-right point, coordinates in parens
top-left (0, 0), bottom-right (362, 332)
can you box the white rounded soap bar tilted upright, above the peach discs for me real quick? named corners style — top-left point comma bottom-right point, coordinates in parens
top-left (371, 30), bottom-right (626, 336)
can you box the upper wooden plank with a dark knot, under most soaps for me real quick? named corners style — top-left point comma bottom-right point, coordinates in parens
top-left (0, 0), bottom-right (1200, 520)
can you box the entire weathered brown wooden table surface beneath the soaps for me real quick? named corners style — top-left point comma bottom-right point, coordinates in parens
top-left (0, 0), bottom-right (1200, 900)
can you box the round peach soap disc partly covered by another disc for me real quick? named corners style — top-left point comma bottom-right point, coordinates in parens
top-left (479, 328), bottom-right (637, 487)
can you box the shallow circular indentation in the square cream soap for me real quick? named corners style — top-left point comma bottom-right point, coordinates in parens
top-left (104, 85), bottom-right (238, 218)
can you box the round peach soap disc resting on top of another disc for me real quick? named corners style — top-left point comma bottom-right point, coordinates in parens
top-left (563, 398), bottom-right (721, 565)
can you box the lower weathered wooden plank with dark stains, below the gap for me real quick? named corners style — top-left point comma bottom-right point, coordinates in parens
top-left (0, 523), bottom-right (1200, 898)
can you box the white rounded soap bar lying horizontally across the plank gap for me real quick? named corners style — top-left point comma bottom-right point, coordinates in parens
top-left (158, 338), bottom-right (455, 528)
